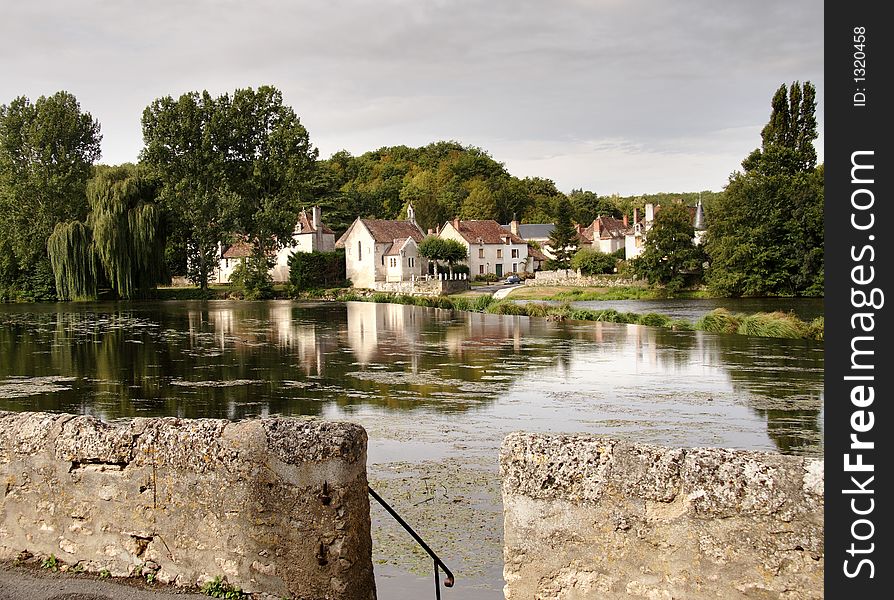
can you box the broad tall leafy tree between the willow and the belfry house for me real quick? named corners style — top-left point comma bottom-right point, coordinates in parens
top-left (142, 86), bottom-right (317, 288)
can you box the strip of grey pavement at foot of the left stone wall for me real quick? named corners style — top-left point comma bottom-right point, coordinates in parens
top-left (0, 564), bottom-right (208, 600)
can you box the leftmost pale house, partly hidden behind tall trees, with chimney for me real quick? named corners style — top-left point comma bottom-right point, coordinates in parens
top-left (214, 206), bottom-right (335, 283)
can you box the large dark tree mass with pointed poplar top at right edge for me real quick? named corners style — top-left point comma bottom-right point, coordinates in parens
top-left (706, 82), bottom-right (824, 296)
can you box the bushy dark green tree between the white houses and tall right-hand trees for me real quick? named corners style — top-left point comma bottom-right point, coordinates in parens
top-left (633, 204), bottom-right (703, 291)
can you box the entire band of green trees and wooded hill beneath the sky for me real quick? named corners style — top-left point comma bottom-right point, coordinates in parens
top-left (0, 82), bottom-right (823, 300)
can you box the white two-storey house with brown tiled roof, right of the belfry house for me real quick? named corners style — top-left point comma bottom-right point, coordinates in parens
top-left (438, 219), bottom-right (533, 277)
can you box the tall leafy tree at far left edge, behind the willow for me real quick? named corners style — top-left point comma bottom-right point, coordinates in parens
top-left (0, 91), bottom-right (102, 299)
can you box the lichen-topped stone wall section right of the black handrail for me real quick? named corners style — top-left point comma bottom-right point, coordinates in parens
top-left (500, 433), bottom-right (824, 600)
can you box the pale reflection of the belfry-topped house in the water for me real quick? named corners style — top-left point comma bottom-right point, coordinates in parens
top-left (346, 302), bottom-right (424, 372)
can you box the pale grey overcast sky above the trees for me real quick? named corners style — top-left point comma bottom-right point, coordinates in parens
top-left (0, 0), bottom-right (824, 196)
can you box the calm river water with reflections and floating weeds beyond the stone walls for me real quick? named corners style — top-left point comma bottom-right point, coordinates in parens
top-left (0, 301), bottom-right (823, 600)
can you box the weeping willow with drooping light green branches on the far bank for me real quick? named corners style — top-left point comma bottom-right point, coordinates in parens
top-left (47, 164), bottom-right (165, 299)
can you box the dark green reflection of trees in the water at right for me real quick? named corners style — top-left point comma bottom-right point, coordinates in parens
top-left (696, 332), bottom-right (824, 454)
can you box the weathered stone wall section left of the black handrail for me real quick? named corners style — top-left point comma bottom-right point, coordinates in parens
top-left (0, 412), bottom-right (375, 599)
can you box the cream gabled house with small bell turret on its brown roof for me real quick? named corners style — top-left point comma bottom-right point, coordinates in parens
top-left (335, 205), bottom-right (428, 289)
